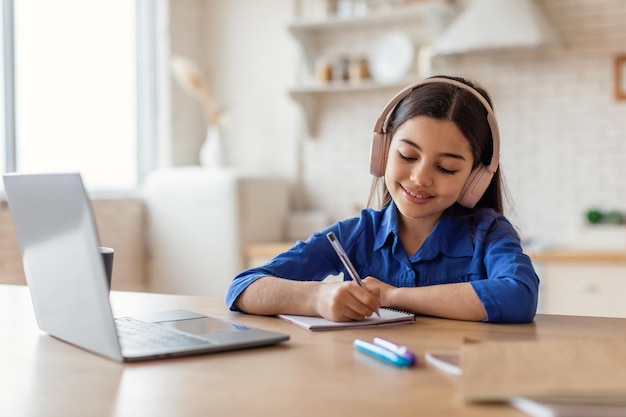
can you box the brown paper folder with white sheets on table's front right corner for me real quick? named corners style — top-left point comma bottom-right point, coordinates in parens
top-left (425, 338), bottom-right (626, 417)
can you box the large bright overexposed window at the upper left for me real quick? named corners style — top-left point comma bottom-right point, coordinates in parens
top-left (2, 0), bottom-right (151, 190)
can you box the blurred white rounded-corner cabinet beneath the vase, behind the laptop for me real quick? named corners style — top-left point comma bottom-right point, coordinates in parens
top-left (144, 166), bottom-right (289, 297)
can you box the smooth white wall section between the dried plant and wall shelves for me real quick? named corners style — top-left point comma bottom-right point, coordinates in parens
top-left (200, 0), bottom-right (298, 176)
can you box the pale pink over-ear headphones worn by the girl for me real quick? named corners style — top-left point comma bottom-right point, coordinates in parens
top-left (370, 77), bottom-right (500, 208)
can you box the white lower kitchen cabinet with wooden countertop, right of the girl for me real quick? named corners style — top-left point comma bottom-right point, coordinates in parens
top-left (531, 250), bottom-right (626, 317)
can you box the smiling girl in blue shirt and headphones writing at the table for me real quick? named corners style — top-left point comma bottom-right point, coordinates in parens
top-left (226, 76), bottom-right (539, 323)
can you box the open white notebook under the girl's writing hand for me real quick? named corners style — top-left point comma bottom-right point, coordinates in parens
top-left (278, 307), bottom-right (415, 331)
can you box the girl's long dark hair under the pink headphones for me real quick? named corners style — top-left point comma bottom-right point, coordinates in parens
top-left (368, 75), bottom-right (503, 214)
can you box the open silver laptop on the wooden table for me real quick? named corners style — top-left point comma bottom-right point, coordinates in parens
top-left (3, 173), bottom-right (289, 361)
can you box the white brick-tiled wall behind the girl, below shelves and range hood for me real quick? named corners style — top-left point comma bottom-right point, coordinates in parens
top-left (303, 0), bottom-right (626, 244)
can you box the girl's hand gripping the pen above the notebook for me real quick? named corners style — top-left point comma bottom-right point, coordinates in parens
top-left (316, 281), bottom-right (381, 321)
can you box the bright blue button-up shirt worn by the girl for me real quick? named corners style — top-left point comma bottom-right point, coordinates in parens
top-left (226, 202), bottom-right (539, 323)
